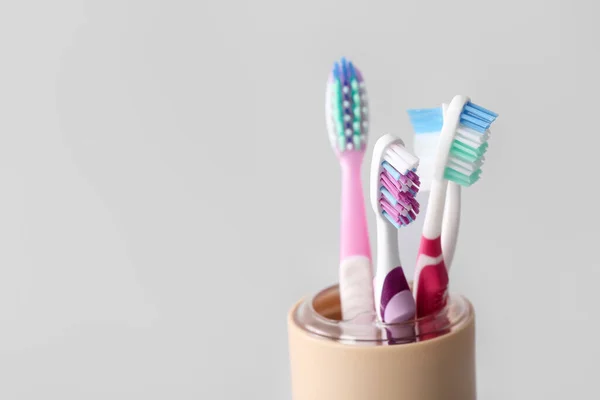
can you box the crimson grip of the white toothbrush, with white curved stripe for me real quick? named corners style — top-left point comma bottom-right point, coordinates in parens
top-left (416, 236), bottom-right (448, 318)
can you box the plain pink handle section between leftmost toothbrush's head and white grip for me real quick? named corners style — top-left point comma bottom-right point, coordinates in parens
top-left (340, 152), bottom-right (371, 260)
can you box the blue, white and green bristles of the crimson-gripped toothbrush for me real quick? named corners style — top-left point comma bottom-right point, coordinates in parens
top-left (444, 102), bottom-right (498, 186)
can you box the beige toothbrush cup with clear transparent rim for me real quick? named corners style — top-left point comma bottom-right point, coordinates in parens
top-left (288, 286), bottom-right (476, 400)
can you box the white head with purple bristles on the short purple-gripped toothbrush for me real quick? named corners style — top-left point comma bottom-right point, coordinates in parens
top-left (370, 134), bottom-right (420, 229)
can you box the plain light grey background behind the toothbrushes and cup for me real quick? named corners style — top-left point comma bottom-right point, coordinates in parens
top-left (0, 0), bottom-right (600, 400)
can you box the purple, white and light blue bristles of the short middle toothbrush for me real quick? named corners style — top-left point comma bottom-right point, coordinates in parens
top-left (379, 145), bottom-right (420, 229)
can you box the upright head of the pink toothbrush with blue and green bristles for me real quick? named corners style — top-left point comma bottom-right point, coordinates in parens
top-left (325, 58), bottom-right (369, 153)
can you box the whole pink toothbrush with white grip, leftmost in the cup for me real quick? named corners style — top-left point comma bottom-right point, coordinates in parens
top-left (325, 58), bottom-right (375, 320)
